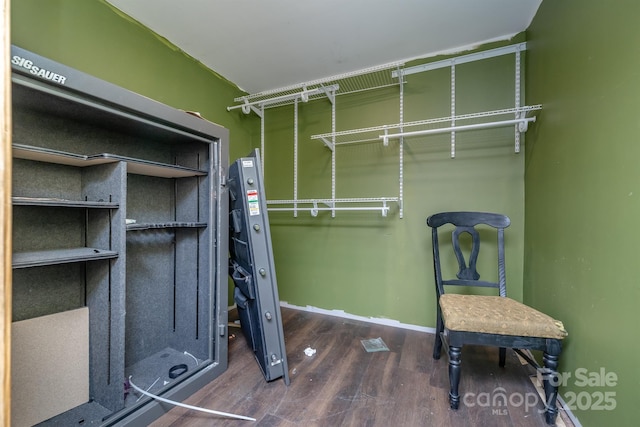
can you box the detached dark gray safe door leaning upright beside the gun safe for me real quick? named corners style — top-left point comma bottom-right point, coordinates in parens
top-left (228, 149), bottom-right (289, 385)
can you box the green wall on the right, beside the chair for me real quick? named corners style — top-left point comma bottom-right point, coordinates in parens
top-left (524, 0), bottom-right (640, 426)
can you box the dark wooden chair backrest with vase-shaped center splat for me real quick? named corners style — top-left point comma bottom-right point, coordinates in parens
top-left (427, 212), bottom-right (511, 298)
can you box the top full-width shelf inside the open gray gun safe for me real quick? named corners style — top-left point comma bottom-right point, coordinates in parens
top-left (13, 144), bottom-right (207, 178)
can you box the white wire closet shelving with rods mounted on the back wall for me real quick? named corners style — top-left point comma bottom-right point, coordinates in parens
top-left (227, 43), bottom-right (542, 218)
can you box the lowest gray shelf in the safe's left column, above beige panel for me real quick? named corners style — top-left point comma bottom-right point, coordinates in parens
top-left (12, 248), bottom-right (118, 268)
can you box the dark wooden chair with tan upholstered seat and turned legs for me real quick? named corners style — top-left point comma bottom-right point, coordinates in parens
top-left (427, 212), bottom-right (567, 425)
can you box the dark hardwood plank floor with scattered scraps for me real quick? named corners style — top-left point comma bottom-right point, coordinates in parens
top-left (152, 308), bottom-right (572, 427)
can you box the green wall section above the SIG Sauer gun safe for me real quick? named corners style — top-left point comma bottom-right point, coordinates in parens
top-left (11, 0), bottom-right (257, 158)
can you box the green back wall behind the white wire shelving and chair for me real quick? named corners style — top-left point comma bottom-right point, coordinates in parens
top-left (258, 40), bottom-right (524, 327)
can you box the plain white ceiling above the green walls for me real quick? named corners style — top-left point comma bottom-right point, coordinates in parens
top-left (107, 0), bottom-right (542, 93)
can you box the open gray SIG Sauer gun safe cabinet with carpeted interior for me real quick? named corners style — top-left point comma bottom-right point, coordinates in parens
top-left (11, 46), bottom-right (228, 426)
